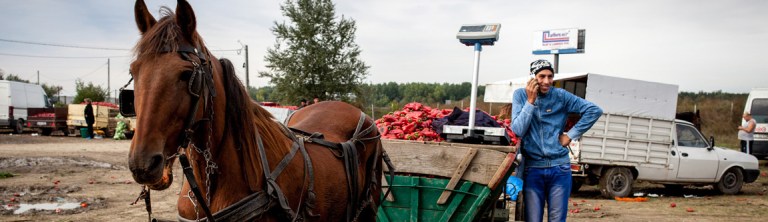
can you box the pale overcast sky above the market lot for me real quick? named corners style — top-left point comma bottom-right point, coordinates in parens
top-left (0, 0), bottom-right (768, 95)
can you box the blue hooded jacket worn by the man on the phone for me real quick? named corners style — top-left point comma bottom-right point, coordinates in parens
top-left (511, 87), bottom-right (603, 168)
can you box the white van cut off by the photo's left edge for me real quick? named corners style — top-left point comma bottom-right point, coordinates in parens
top-left (0, 80), bottom-right (51, 133)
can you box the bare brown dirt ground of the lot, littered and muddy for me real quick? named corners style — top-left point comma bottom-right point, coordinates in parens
top-left (0, 133), bottom-right (768, 222)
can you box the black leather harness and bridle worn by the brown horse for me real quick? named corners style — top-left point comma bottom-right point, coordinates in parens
top-left (124, 44), bottom-right (394, 221)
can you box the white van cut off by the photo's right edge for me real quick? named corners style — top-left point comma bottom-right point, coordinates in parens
top-left (741, 88), bottom-right (768, 159)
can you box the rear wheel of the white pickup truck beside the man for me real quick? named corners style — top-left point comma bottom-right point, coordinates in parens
top-left (600, 167), bottom-right (634, 198)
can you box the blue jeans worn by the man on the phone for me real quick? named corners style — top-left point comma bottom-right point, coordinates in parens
top-left (523, 164), bottom-right (571, 221)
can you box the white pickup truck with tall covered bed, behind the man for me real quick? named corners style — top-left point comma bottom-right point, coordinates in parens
top-left (486, 73), bottom-right (760, 198)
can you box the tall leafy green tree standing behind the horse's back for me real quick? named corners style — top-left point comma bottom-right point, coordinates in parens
top-left (259, 0), bottom-right (369, 103)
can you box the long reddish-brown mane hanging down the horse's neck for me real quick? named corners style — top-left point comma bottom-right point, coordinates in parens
top-left (219, 59), bottom-right (290, 191)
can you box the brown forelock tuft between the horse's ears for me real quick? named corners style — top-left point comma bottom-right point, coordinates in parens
top-left (133, 6), bottom-right (210, 58)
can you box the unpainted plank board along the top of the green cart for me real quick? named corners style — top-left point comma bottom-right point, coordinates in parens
top-left (383, 140), bottom-right (514, 185)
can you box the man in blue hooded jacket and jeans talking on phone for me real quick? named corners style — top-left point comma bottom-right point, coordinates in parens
top-left (511, 60), bottom-right (603, 221)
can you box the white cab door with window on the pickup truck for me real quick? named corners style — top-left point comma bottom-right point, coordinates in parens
top-left (676, 123), bottom-right (718, 182)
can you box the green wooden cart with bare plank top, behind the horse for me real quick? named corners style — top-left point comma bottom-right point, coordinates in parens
top-left (377, 140), bottom-right (516, 222)
